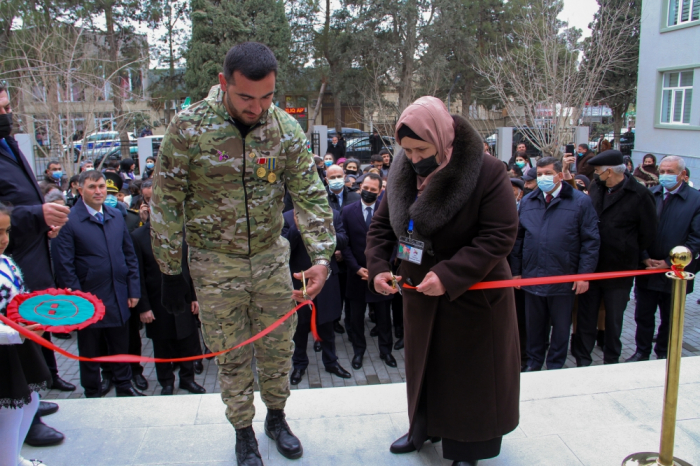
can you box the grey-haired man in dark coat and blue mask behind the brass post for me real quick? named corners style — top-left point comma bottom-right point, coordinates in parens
top-left (627, 155), bottom-right (700, 362)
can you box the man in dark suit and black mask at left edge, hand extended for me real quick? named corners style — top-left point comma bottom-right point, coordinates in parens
top-left (0, 86), bottom-right (69, 447)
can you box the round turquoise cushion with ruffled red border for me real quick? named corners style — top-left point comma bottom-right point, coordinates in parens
top-left (7, 288), bottom-right (105, 333)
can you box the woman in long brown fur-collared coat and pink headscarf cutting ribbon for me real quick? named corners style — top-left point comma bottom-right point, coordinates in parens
top-left (366, 97), bottom-right (520, 465)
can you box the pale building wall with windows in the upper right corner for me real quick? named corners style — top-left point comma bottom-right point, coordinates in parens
top-left (632, 0), bottom-right (700, 182)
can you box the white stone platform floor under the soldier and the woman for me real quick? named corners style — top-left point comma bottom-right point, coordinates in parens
top-left (22, 357), bottom-right (700, 466)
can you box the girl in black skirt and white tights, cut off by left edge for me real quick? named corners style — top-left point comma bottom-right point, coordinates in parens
top-left (0, 203), bottom-right (51, 466)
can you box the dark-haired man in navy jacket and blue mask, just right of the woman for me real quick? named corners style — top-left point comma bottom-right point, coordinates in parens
top-left (511, 157), bottom-right (600, 372)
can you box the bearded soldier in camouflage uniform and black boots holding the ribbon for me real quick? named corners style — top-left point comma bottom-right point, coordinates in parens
top-left (151, 42), bottom-right (335, 466)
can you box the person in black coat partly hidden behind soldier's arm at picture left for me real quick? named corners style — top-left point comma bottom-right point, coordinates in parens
top-left (131, 222), bottom-right (206, 395)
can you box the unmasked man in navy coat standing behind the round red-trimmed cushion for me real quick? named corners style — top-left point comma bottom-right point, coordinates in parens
top-left (51, 170), bottom-right (143, 398)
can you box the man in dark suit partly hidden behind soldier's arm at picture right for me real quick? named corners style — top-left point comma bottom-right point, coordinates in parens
top-left (282, 210), bottom-right (350, 385)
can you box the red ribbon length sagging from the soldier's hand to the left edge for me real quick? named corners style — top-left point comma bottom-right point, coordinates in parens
top-left (0, 301), bottom-right (321, 363)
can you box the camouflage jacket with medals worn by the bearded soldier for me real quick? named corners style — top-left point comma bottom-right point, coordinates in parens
top-left (151, 86), bottom-right (335, 275)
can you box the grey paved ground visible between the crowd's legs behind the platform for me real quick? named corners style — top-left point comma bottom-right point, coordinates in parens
top-left (42, 284), bottom-right (700, 399)
